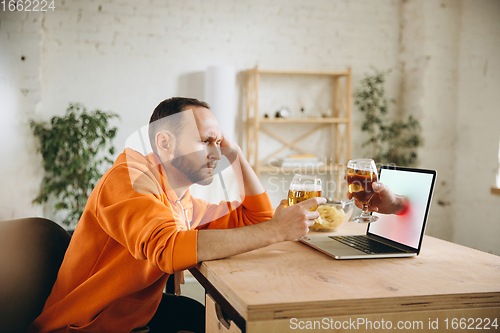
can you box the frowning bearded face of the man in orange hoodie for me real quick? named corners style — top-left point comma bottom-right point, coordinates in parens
top-left (171, 106), bottom-right (222, 185)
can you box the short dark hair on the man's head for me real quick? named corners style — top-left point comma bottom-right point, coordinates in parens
top-left (148, 97), bottom-right (210, 154)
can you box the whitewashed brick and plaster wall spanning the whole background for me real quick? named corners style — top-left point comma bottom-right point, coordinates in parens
top-left (0, 0), bottom-right (500, 254)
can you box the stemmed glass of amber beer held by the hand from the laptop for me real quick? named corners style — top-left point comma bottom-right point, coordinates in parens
top-left (346, 159), bottom-right (378, 223)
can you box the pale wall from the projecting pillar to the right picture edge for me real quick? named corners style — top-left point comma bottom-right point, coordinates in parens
top-left (399, 0), bottom-right (500, 254)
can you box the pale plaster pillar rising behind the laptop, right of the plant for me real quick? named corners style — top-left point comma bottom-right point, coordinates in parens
top-left (399, 0), bottom-right (461, 240)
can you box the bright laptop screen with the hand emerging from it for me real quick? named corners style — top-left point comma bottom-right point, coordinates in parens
top-left (368, 166), bottom-right (436, 249)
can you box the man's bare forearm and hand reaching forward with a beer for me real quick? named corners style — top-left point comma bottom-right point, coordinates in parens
top-left (197, 198), bottom-right (326, 262)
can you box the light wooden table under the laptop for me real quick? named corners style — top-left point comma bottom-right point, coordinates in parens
top-left (191, 222), bottom-right (500, 332)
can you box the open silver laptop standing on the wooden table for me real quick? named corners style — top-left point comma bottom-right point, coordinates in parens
top-left (300, 166), bottom-right (437, 259)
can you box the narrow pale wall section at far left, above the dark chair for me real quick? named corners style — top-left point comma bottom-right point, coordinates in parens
top-left (0, 11), bottom-right (43, 220)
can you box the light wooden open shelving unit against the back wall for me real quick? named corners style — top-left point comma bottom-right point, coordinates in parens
top-left (245, 67), bottom-right (352, 182)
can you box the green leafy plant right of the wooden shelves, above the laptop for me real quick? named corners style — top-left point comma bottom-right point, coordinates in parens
top-left (354, 68), bottom-right (422, 166)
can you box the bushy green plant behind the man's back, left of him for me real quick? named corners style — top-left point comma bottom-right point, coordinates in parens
top-left (29, 103), bottom-right (119, 226)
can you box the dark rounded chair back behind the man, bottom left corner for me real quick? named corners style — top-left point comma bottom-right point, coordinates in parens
top-left (0, 217), bottom-right (71, 333)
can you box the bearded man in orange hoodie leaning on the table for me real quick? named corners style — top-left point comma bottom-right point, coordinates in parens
top-left (28, 98), bottom-right (325, 333)
